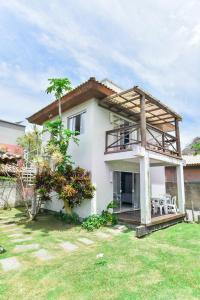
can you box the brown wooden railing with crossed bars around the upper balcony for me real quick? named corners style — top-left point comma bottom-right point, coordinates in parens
top-left (105, 124), bottom-right (181, 157)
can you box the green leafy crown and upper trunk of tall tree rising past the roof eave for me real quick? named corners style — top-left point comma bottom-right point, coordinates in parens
top-left (46, 78), bottom-right (72, 119)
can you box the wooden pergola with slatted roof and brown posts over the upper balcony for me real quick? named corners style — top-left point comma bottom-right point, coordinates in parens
top-left (99, 86), bottom-right (182, 156)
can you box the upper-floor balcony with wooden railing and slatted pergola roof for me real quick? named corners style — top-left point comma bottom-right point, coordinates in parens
top-left (99, 86), bottom-right (182, 158)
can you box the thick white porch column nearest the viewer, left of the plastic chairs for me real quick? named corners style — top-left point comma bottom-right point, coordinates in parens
top-left (140, 153), bottom-right (151, 224)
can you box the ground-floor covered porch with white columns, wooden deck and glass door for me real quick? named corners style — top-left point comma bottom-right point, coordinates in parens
top-left (105, 146), bottom-right (185, 233)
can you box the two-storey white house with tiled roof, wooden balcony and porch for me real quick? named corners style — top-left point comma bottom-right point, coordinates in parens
top-left (28, 78), bottom-right (185, 234)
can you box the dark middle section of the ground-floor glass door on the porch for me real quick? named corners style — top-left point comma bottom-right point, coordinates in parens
top-left (121, 172), bottom-right (133, 207)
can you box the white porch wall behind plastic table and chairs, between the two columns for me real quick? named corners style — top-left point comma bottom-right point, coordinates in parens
top-left (150, 167), bottom-right (166, 197)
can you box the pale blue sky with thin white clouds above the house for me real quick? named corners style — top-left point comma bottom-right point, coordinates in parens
top-left (0, 0), bottom-right (200, 146)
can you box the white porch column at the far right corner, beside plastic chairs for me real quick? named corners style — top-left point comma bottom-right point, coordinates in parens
top-left (176, 164), bottom-right (185, 213)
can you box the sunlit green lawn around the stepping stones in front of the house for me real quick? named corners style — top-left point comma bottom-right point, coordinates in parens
top-left (0, 209), bottom-right (200, 300)
